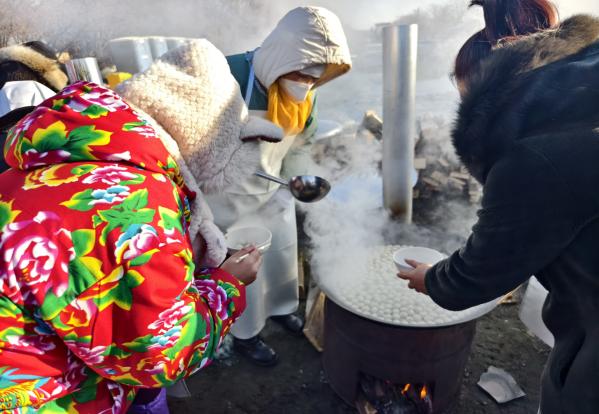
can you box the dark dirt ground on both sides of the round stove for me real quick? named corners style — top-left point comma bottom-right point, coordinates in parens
top-left (169, 305), bottom-right (549, 414)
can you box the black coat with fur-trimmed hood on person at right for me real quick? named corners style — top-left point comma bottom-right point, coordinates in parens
top-left (426, 16), bottom-right (599, 414)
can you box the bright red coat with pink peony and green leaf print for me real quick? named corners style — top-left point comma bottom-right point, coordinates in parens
top-left (0, 83), bottom-right (245, 414)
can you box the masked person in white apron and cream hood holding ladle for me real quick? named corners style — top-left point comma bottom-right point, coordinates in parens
top-left (208, 7), bottom-right (351, 365)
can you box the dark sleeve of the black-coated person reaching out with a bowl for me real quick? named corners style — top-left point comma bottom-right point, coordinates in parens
top-left (425, 148), bottom-right (588, 310)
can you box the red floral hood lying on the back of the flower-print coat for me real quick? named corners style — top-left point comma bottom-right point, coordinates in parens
top-left (4, 82), bottom-right (178, 175)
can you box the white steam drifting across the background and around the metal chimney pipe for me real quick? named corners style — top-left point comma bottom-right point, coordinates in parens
top-left (0, 0), bottom-right (599, 298)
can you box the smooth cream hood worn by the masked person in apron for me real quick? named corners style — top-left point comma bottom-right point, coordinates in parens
top-left (254, 7), bottom-right (352, 89)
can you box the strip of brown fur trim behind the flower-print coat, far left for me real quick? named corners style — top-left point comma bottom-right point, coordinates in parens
top-left (0, 45), bottom-right (68, 91)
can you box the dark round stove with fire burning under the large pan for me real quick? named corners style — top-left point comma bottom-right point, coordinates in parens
top-left (323, 299), bottom-right (476, 414)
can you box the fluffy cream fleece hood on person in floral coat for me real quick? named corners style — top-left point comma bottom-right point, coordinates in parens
top-left (118, 40), bottom-right (283, 193)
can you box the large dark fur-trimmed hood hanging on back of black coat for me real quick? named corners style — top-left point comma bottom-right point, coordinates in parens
top-left (453, 15), bottom-right (599, 183)
